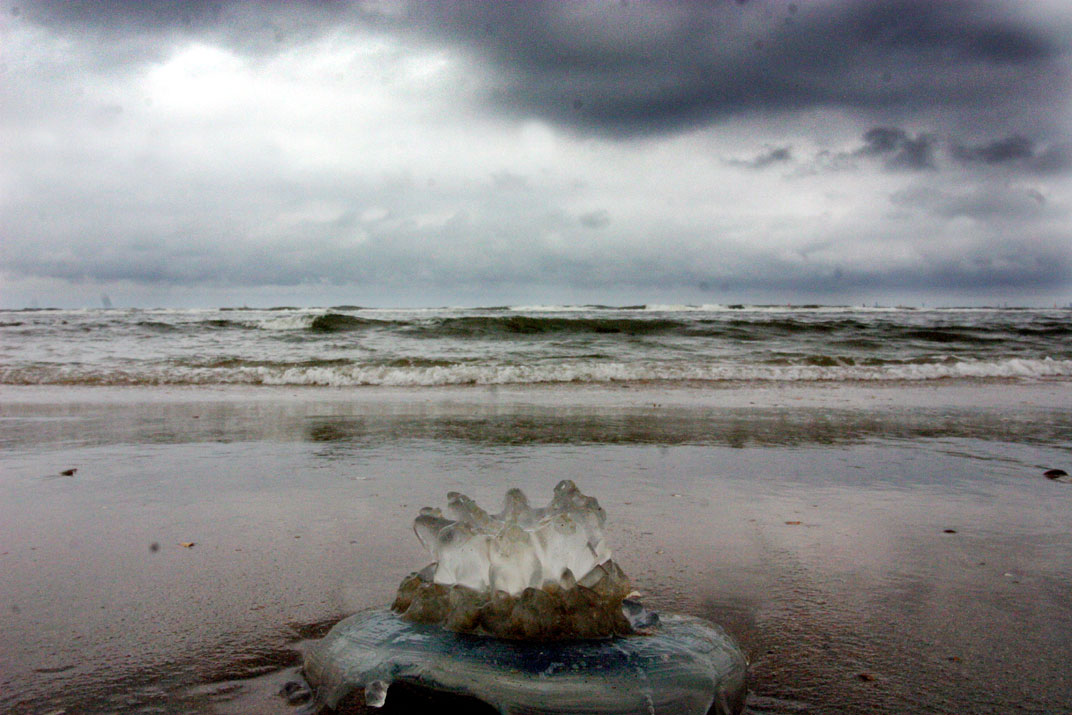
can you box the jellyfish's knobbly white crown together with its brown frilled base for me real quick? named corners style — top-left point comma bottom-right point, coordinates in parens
top-left (391, 479), bottom-right (634, 640)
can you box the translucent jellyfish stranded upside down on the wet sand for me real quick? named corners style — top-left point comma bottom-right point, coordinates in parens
top-left (304, 480), bottom-right (746, 715)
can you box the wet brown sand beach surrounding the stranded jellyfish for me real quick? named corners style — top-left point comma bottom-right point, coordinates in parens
top-left (0, 382), bottom-right (1072, 713)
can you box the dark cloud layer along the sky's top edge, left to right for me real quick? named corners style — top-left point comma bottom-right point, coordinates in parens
top-left (21, 0), bottom-right (1069, 138)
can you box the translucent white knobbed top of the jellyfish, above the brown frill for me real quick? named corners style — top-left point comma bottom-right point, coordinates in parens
top-left (414, 479), bottom-right (611, 596)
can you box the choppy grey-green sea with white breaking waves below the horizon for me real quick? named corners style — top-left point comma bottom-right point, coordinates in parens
top-left (0, 304), bottom-right (1072, 387)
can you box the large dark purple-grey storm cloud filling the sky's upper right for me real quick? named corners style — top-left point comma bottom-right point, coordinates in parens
top-left (403, 0), bottom-right (1068, 134)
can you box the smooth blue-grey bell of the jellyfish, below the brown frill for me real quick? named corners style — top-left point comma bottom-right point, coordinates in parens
top-left (304, 609), bottom-right (747, 715)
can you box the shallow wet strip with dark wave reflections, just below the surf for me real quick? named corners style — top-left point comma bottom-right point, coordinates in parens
top-left (0, 402), bottom-right (1072, 448)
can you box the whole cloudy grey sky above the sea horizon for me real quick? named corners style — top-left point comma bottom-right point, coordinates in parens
top-left (0, 0), bottom-right (1072, 308)
